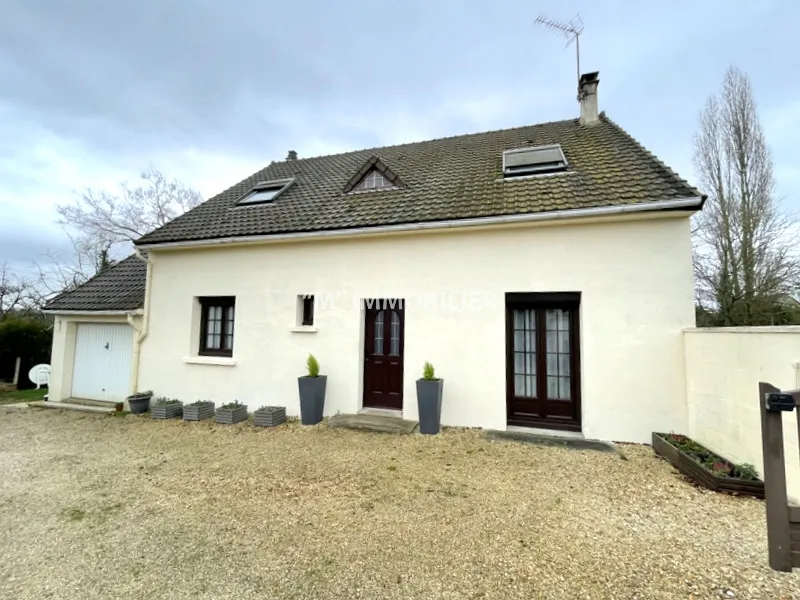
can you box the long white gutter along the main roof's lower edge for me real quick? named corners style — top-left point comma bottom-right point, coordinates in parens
top-left (137, 196), bottom-right (705, 250)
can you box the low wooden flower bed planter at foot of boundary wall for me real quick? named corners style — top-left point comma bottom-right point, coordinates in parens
top-left (653, 433), bottom-right (764, 498)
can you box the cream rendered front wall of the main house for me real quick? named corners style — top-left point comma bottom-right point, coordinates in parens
top-left (139, 213), bottom-right (694, 442)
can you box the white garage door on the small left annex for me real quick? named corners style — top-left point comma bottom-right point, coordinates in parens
top-left (72, 323), bottom-right (133, 402)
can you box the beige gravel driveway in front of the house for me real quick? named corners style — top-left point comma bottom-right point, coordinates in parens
top-left (0, 407), bottom-right (800, 600)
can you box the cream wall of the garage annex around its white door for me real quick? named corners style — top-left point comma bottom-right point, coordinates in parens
top-left (47, 314), bottom-right (141, 402)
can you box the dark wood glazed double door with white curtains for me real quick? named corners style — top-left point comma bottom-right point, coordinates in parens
top-left (506, 292), bottom-right (581, 431)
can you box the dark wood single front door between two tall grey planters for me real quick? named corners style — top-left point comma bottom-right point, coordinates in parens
top-left (364, 298), bottom-right (405, 409)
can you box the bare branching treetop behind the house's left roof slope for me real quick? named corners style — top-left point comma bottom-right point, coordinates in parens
top-left (57, 167), bottom-right (203, 249)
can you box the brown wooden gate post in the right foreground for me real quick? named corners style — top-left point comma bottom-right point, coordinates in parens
top-left (758, 382), bottom-right (792, 571)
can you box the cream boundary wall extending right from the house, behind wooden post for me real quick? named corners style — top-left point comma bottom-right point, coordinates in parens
top-left (676, 327), bottom-right (800, 502)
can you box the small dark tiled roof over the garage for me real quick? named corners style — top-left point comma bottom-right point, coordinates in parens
top-left (44, 254), bottom-right (147, 311)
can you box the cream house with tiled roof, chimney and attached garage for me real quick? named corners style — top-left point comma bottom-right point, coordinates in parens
top-left (48, 73), bottom-right (704, 442)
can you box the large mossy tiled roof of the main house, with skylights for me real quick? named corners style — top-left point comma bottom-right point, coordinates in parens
top-left (137, 114), bottom-right (700, 245)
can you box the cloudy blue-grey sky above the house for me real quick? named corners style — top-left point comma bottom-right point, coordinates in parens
top-left (0, 0), bottom-right (800, 266)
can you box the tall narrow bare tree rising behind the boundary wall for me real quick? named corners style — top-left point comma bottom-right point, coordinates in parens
top-left (694, 67), bottom-right (800, 325)
